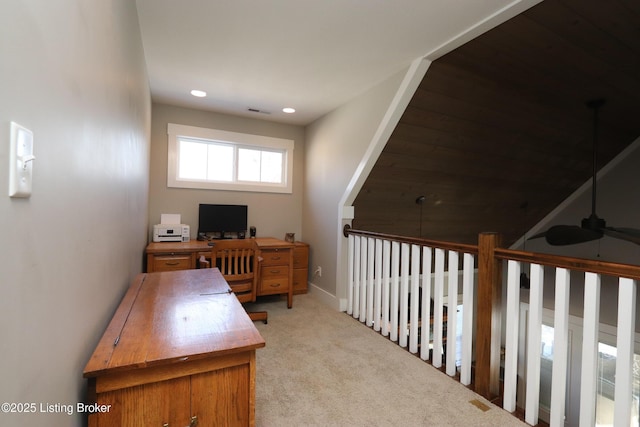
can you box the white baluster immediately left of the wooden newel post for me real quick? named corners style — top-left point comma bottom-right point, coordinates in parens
top-left (460, 253), bottom-right (475, 385)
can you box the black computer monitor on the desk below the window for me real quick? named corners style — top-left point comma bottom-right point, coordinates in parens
top-left (198, 204), bottom-right (247, 236)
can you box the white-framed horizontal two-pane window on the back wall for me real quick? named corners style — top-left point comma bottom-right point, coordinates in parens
top-left (167, 123), bottom-right (293, 193)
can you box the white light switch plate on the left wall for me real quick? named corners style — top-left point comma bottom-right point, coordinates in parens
top-left (9, 122), bottom-right (35, 198)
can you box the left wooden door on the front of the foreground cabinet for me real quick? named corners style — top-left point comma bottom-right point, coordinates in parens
top-left (89, 377), bottom-right (191, 427)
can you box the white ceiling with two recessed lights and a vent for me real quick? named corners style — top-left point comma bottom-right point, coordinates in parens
top-left (137, 0), bottom-right (528, 125)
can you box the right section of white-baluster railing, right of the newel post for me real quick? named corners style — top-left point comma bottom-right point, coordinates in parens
top-left (501, 251), bottom-right (638, 427)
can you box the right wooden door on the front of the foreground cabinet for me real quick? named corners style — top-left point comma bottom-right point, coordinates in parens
top-left (191, 364), bottom-right (254, 426)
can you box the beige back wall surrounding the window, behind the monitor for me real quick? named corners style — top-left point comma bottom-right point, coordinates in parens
top-left (149, 103), bottom-right (305, 240)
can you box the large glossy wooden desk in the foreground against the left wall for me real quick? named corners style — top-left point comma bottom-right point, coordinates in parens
top-left (84, 268), bottom-right (265, 427)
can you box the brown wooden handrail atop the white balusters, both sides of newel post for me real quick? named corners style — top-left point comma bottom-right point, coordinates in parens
top-left (343, 225), bottom-right (640, 280)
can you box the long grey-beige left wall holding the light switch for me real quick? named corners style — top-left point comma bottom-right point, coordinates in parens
top-left (0, 0), bottom-right (151, 426)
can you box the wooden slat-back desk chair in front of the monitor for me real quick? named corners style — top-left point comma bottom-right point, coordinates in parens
top-left (200, 239), bottom-right (267, 324)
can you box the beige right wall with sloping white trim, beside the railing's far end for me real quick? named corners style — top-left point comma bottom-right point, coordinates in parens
top-left (303, 0), bottom-right (541, 308)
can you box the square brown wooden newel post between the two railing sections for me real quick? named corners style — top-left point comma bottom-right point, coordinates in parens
top-left (475, 233), bottom-right (502, 400)
